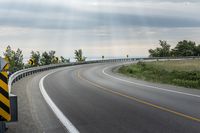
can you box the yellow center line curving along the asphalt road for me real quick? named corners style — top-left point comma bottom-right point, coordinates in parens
top-left (77, 71), bottom-right (200, 123)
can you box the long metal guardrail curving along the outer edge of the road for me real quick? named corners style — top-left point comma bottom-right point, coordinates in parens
top-left (8, 56), bottom-right (200, 93)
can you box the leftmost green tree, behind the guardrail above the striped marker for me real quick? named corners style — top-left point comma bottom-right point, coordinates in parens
top-left (4, 46), bottom-right (24, 72)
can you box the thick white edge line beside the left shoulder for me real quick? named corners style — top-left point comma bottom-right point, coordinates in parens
top-left (39, 71), bottom-right (79, 133)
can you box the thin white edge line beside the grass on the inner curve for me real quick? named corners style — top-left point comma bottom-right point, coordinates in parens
top-left (102, 66), bottom-right (200, 98)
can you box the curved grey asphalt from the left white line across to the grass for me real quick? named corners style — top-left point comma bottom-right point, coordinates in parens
top-left (40, 63), bottom-right (200, 133)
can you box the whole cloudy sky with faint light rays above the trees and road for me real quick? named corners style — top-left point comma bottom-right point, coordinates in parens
top-left (0, 0), bottom-right (200, 60)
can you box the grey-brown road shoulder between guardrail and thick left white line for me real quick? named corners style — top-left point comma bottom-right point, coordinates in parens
top-left (7, 72), bottom-right (66, 133)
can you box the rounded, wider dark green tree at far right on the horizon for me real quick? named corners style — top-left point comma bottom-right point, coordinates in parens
top-left (172, 40), bottom-right (196, 56)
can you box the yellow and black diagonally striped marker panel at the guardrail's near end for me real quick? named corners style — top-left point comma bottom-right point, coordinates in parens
top-left (0, 72), bottom-right (11, 121)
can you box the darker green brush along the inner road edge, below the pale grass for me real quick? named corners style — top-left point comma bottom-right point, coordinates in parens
top-left (118, 62), bottom-right (200, 89)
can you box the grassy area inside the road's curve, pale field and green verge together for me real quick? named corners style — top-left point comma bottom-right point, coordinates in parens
top-left (118, 59), bottom-right (200, 89)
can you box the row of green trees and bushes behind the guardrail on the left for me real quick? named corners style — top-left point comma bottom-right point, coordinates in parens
top-left (3, 46), bottom-right (86, 73)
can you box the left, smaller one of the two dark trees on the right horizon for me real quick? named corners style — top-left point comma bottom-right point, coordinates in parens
top-left (149, 40), bottom-right (171, 57)
